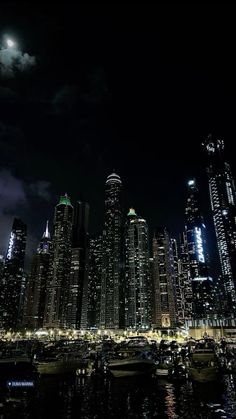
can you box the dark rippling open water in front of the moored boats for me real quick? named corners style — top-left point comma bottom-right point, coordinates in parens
top-left (0, 376), bottom-right (236, 419)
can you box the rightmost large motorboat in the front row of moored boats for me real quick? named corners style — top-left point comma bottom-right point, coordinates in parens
top-left (187, 341), bottom-right (220, 383)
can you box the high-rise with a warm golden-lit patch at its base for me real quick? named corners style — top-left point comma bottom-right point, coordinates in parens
top-left (153, 228), bottom-right (176, 328)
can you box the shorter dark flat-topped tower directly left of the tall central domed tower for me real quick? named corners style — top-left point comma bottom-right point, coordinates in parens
top-left (87, 235), bottom-right (102, 329)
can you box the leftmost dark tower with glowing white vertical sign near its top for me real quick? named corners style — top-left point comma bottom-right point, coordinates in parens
top-left (0, 218), bottom-right (27, 329)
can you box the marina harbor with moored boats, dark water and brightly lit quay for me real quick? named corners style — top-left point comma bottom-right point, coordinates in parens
top-left (0, 334), bottom-right (236, 419)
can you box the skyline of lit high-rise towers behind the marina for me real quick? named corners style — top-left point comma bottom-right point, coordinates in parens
top-left (0, 135), bottom-right (236, 330)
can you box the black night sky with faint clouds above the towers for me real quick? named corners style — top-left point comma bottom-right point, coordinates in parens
top-left (0, 1), bottom-right (236, 276)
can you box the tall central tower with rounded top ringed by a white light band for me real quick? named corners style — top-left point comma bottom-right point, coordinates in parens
top-left (100, 173), bottom-right (122, 329)
